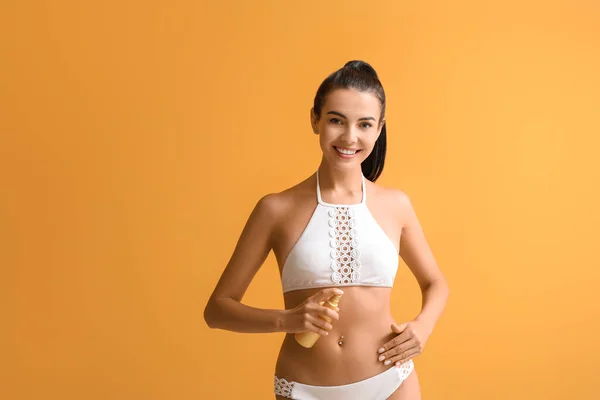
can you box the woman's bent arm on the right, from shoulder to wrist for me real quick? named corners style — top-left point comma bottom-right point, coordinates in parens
top-left (400, 192), bottom-right (450, 333)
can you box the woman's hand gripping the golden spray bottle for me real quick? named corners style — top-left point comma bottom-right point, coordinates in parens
top-left (282, 288), bottom-right (344, 336)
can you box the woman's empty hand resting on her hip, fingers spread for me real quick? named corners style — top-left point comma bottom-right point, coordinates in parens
top-left (377, 320), bottom-right (431, 366)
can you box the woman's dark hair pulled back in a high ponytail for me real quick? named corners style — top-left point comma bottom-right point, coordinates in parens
top-left (313, 60), bottom-right (386, 182)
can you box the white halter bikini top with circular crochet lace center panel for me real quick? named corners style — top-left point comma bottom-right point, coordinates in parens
top-left (281, 171), bottom-right (398, 293)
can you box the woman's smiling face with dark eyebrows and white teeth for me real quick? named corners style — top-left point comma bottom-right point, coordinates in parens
top-left (310, 89), bottom-right (385, 168)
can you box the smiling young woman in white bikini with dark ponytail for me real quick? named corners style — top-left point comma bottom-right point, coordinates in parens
top-left (204, 61), bottom-right (448, 400)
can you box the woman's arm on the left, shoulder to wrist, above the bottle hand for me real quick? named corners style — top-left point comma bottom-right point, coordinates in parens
top-left (204, 194), bottom-right (285, 333)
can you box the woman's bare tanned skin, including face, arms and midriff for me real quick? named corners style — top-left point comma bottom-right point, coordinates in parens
top-left (205, 89), bottom-right (448, 400)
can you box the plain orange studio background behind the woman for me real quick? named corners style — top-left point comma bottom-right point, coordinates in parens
top-left (0, 0), bottom-right (600, 400)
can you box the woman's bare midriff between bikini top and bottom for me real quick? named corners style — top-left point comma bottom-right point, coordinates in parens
top-left (275, 286), bottom-right (396, 386)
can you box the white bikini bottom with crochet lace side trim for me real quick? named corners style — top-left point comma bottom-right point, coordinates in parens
top-left (275, 360), bottom-right (414, 400)
